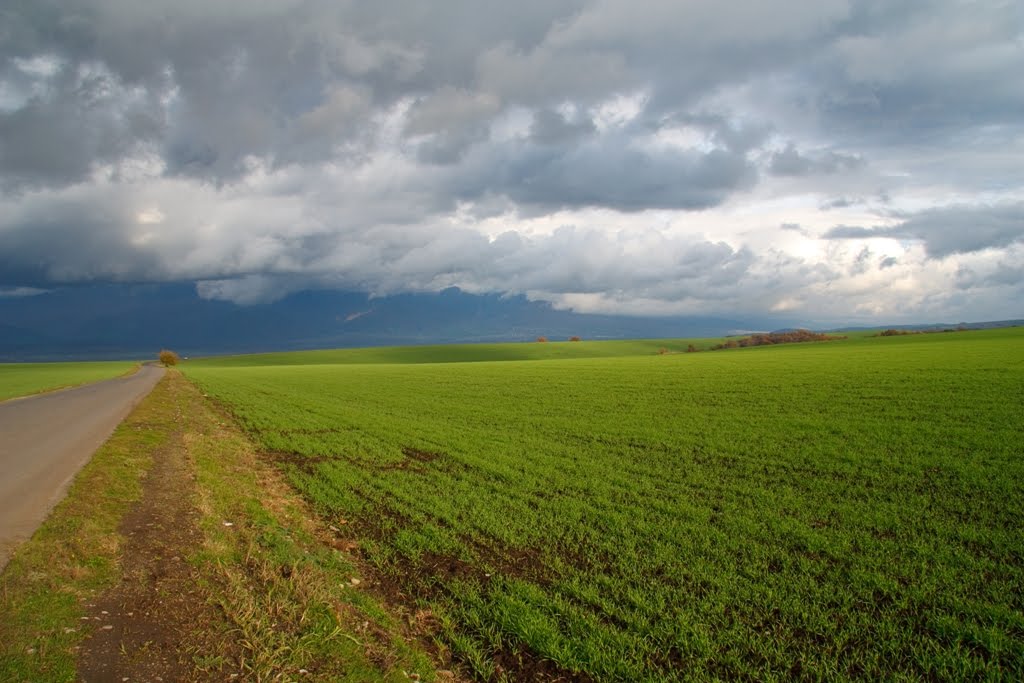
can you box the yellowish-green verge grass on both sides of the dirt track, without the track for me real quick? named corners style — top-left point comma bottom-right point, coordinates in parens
top-left (0, 371), bottom-right (452, 681)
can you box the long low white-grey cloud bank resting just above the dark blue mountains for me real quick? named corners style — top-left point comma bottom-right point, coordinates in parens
top-left (0, 176), bottom-right (776, 312)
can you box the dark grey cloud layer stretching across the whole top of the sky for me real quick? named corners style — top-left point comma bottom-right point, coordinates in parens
top-left (0, 0), bottom-right (1024, 188)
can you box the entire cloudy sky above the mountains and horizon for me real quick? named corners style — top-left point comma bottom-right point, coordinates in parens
top-left (0, 0), bottom-right (1024, 323)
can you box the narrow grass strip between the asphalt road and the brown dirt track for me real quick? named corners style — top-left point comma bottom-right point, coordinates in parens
top-left (0, 368), bottom-right (174, 682)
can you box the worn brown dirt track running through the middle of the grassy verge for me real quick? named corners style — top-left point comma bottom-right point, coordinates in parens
top-left (78, 382), bottom-right (238, 683)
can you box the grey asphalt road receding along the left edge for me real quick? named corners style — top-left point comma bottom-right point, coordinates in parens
top-left (0, 366), bottom-right (164, 569)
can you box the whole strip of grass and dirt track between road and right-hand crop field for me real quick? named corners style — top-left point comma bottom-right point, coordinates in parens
top-left (0, 371), bottom-right (448, 683)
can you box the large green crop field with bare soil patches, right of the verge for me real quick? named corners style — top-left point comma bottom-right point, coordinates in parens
top-left (184, 329), bottom-right (1024, 681)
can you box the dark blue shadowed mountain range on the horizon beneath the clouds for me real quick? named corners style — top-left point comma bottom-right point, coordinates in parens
top-left (0, 284), bottom-right (792, 361)
